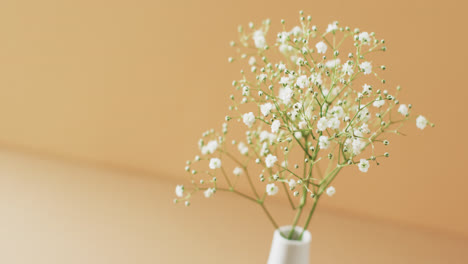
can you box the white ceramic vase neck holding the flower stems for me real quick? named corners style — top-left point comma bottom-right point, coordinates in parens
top-left (268, 226), bottom-right (312, 264)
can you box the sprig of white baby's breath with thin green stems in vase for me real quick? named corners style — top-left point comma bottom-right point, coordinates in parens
top-left (175, 12), bottom-right (433, 239)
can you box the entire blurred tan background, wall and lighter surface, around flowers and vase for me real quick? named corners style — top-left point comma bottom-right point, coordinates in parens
top-left (0, 0), bottom-right (468, 264)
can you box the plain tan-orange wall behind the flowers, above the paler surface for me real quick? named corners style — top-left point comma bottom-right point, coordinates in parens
top-left (0, 0), bottom-right (468, 263)
